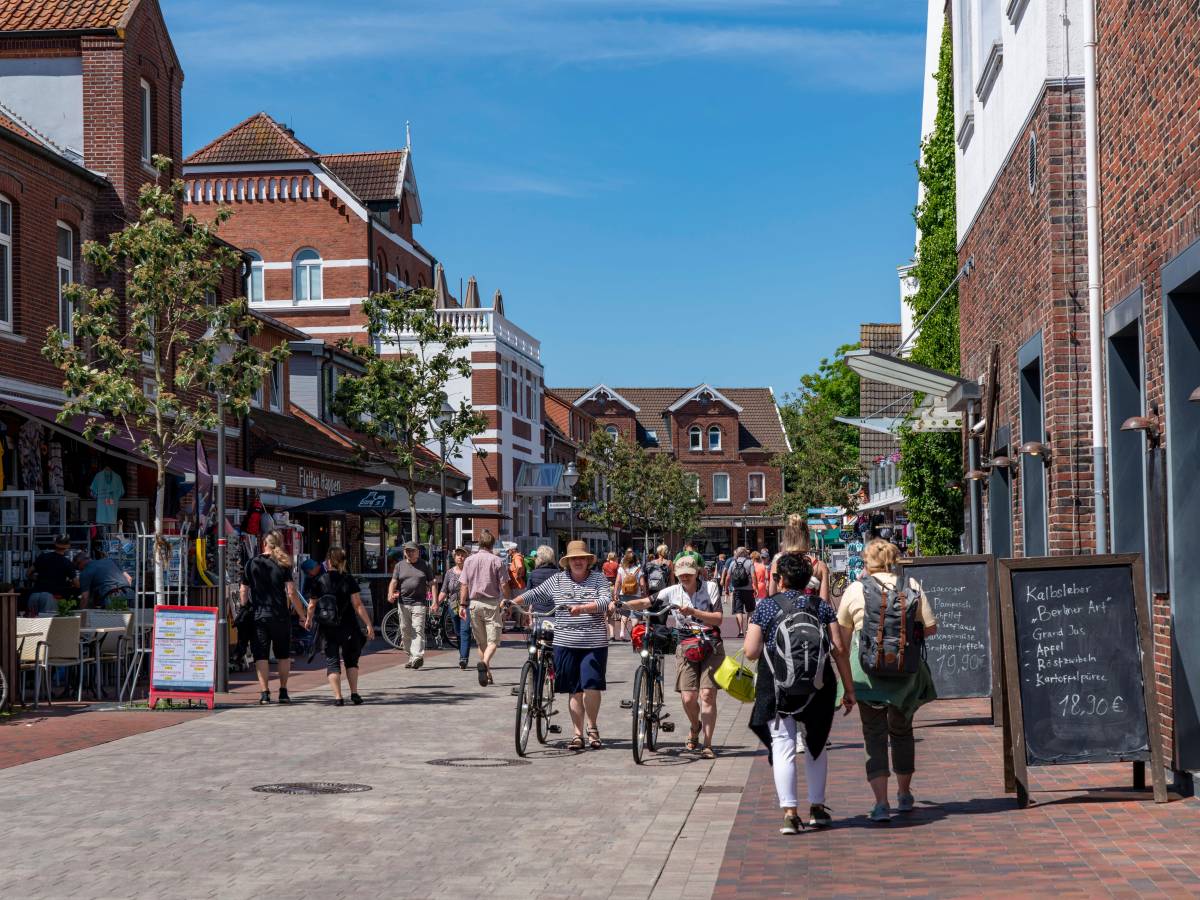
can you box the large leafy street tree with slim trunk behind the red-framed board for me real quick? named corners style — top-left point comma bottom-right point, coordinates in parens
top-left (42, 156), bottom-right (288, 596)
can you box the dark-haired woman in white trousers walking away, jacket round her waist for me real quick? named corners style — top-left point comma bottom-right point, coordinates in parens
top-left (743, 552), bottom-right (854, 834)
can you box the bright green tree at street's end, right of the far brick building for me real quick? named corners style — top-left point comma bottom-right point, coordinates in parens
top-left (773, 344), bottom-right (859, 515)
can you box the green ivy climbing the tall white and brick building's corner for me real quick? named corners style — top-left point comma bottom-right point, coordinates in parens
top-left (900, 22), bottom-right (962, 554)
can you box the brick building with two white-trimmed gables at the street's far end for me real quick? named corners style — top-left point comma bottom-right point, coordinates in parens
top-left (553, 384), bottom-right (790, 556)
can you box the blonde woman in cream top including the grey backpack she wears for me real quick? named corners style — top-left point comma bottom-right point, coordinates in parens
top-left (838, 539), bottom-right (937, 822)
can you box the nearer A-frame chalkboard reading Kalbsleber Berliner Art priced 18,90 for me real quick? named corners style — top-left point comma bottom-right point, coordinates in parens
top-left (1000, 554), bottom-right (1166, 806)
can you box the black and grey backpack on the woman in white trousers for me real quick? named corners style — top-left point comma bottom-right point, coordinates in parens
top-left (767, 590), bottom-right (830, 715)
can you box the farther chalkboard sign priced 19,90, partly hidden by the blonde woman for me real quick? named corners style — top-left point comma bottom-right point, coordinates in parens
top-left (901, 556), bottom-right (998, 700)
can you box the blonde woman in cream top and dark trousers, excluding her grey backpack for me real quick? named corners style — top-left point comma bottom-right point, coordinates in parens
top-left (838, 538), bottom-right (937, 822)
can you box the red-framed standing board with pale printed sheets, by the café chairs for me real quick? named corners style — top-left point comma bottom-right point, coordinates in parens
top-left (150, 606), bottom-right (217, 709)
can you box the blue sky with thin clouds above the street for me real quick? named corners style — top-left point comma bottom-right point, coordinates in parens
top-left (162, 0), bottom-right (925, 394)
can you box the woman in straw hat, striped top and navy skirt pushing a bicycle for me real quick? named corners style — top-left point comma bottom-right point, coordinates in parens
top-left (514, 541), bottom-right (612, 750)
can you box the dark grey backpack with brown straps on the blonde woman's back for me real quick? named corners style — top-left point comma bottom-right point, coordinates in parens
top-left (858, 572), bottom-right (925, 678)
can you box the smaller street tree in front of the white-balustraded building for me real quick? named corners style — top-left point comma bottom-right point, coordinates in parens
top-left (334, 288), bottom-right (487, 540)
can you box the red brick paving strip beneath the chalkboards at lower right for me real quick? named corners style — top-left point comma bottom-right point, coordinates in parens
top-left (714, 701), bottom-right (1200, 898)
